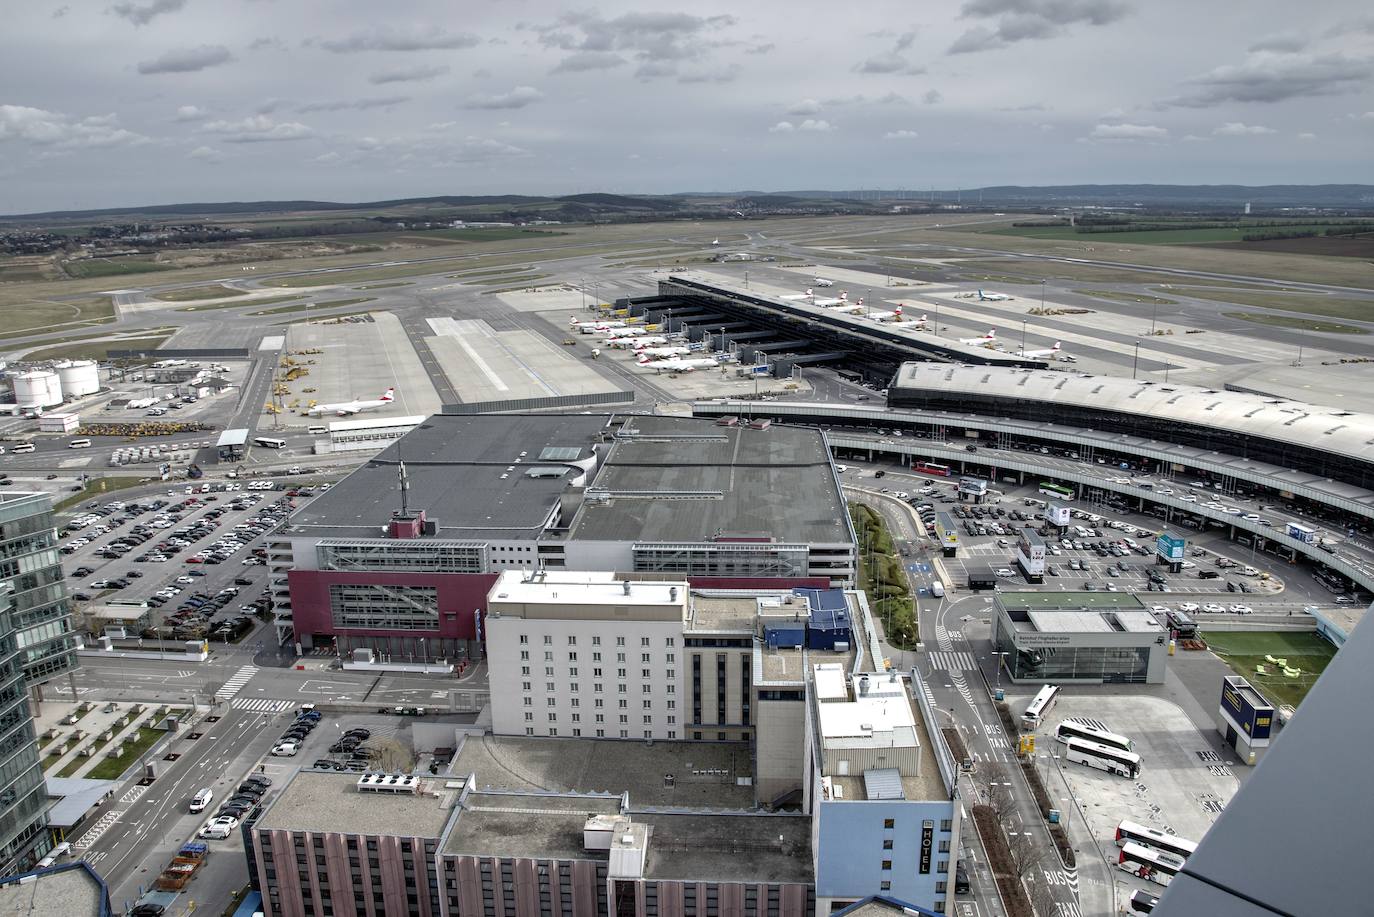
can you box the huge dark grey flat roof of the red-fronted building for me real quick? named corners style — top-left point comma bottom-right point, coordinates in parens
top-left (290, 414), bottom-right (848, 543)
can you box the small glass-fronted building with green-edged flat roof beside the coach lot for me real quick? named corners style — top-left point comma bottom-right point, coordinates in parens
top-left (992, 593), bottom-right (1169, 685)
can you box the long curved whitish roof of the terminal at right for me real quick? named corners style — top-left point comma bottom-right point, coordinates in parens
top-left (892, 363), bottom-right (1374, 462)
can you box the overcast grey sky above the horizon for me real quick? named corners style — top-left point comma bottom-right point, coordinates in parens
top-left (0, 0), bottom-right (1374, 213)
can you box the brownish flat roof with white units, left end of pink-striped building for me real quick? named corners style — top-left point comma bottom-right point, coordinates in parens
top-left (256, 770), bottom-right (459, 837)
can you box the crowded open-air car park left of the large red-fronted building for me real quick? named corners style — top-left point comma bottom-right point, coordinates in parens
top-left (59, 483), bottom-right (324, 639)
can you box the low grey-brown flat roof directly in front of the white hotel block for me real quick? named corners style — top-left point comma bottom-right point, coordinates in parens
top-left (452, 736), bottom-right (754, 810)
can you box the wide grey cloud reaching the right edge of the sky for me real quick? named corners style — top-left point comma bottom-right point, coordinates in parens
top-left (1161, 51), bottom-right (1374, 109)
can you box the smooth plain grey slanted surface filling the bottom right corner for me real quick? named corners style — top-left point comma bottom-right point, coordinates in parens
top-left (1154, 604), bottom-right (1374, 917)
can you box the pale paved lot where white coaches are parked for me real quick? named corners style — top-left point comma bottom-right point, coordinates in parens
top-left (1009, 687), bottom-right (1239, 905)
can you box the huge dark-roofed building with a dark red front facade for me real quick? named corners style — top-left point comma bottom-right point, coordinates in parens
top-left (268, 414), bottom-right (855, 663)
